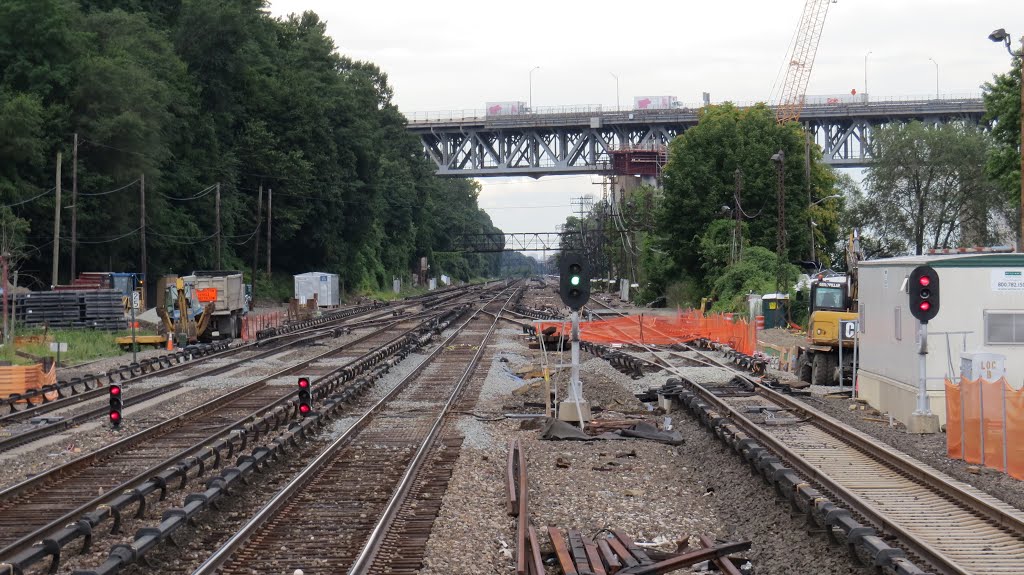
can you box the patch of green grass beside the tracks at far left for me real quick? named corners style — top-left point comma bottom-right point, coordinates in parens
top-left (0, 328), bottom-right (156, 365)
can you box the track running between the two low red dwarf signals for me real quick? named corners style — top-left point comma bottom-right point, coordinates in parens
top-left (0, 292), bottom-right (485, 568)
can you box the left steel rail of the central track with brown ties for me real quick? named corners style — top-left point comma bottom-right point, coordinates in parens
top-left (193, 282), bottom-right (516, 575)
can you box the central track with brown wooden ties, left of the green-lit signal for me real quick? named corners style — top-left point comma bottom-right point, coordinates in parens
top-left (184, 282), bottom-right (516, 575)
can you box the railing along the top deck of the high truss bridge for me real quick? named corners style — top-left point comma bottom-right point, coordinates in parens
top-left (406, 93), bottom-right (981, 126)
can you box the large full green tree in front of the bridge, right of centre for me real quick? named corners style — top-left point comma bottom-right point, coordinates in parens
top-left (658, 104), bottom-right (841, 290)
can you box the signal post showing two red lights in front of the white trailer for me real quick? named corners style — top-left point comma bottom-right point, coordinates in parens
top-left (906, 266), bottom-right (939, 434)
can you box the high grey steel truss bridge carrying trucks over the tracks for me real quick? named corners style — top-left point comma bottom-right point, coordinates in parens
top-left (409, 98), bottom-right (985, 177)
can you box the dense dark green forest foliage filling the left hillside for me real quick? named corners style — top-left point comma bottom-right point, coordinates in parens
top-left (0, 0), bottom-right (501, 290)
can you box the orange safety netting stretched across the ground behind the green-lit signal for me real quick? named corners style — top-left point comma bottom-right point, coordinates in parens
top-left (536, 310), bottom-right (757, 355)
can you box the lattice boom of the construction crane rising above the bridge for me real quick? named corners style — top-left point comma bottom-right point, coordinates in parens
top-left (775, 0), bottom-right (836, 124)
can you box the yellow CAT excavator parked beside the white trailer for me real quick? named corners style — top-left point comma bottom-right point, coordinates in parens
top-left (796, 231), bottom-right (863, 386)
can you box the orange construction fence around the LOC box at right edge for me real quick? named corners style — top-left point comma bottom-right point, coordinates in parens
top-left (946, 378), bottom-right (1024, 479)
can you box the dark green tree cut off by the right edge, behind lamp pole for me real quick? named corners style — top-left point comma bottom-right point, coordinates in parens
top-left (982, 53), bottom-right (1024, 241)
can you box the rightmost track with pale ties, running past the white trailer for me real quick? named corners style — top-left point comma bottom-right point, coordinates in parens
top-left (630, 339), bottom-right (1024, 575)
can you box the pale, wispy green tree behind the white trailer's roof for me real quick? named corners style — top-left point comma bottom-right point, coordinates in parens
top-left (854, 122), bottom-right (1007, 255)
